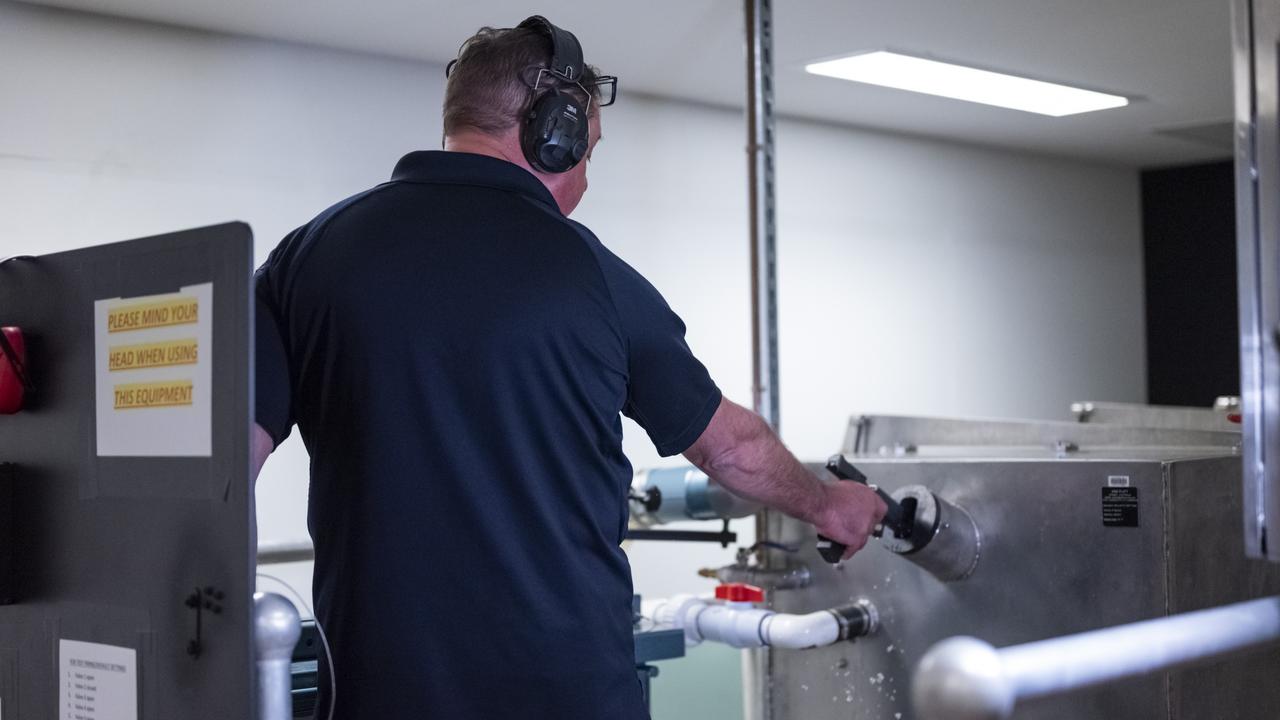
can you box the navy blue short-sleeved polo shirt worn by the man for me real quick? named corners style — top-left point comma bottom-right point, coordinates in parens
top-left (256, 151), bottom-right (721, 720)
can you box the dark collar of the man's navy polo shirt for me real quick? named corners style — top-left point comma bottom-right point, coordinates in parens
top-left (392, 150), bottom-right (559, 213)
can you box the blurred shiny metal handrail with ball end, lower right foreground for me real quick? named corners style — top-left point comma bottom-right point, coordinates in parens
top-left (913, 597), bottom-right (1280, 720)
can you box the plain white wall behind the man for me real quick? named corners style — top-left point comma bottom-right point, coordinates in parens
top-left (0, 1), bottom-right (1146, 707)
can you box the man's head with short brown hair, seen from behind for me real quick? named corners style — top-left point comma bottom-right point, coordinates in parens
top-left (444, 18), bottom-right (613, 214)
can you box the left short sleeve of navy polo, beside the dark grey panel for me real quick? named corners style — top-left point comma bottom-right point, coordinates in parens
top-left (253, 254), bottom-right (293, 447)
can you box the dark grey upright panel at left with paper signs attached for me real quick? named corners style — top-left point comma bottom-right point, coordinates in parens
top-left (0, 223), bottom-right (256, 720)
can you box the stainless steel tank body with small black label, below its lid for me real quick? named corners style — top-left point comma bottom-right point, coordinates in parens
top-left (769, 448), bottom-right (1280, 720)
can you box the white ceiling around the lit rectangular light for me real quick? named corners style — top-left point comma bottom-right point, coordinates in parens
top-left (17, 0), bottom-right (1231, 167)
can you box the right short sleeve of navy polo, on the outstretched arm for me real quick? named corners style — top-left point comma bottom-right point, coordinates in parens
top-left (593, 238), bottom-right (721, 457)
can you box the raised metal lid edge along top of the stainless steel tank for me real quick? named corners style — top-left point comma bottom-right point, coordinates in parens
top-left (841, 415), bottom-right (1240, 454)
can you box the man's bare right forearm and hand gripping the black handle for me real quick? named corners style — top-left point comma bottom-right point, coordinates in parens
top-left (685, 398), bottom-right (886, 557)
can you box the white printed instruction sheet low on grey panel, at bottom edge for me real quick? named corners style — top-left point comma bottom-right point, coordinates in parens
top-left (58, 639), bottom-right (138, 720)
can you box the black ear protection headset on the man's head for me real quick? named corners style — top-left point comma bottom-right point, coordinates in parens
top-left (516, 15), bottom-right (589, 173)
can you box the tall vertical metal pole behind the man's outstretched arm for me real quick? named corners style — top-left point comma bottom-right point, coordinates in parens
top-left (742, 0), bottom-right (780, 720)
